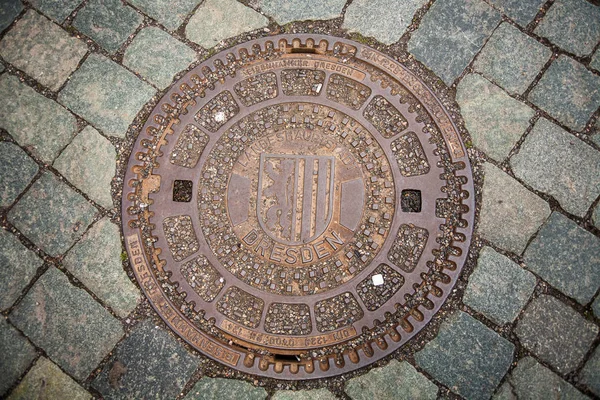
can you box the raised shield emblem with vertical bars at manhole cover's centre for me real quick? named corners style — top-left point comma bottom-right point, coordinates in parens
top-left (256, 153), bottom-right (335, 245)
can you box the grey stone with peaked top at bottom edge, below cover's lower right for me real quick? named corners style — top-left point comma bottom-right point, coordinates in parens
top-left (345, 360), bottom-right (438, 400)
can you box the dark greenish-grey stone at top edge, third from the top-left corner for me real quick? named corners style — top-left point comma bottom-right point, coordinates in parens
top-left (73, 0), bottom-right (144, 53)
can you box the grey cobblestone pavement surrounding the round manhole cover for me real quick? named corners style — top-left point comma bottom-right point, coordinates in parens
top-left (0, 0), bottom-right (600, 399)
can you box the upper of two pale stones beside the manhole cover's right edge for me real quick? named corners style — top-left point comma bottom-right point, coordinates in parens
top-left (456, 74), bottom-right (535, 162)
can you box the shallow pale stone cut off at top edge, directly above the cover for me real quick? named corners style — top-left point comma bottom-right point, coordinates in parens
top-left (258, 0), bottom-right (346, 25)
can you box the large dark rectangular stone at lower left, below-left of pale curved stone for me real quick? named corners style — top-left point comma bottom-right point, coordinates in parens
top-left (10, 267), bottom-right (123, 380)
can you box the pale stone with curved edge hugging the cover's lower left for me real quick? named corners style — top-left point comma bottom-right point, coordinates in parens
top-left (63, 217), bottom-right (140, 317)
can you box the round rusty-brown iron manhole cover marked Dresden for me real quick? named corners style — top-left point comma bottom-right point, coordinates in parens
top-left (123, 35), bottom-right (474, 379)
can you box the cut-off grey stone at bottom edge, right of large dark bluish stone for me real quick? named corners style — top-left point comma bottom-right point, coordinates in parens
top-left (184, 376), bottom-right (266, 400)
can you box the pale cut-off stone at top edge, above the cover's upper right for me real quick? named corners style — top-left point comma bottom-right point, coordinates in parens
top-left (342, 0), bottom-right (426, 44)
